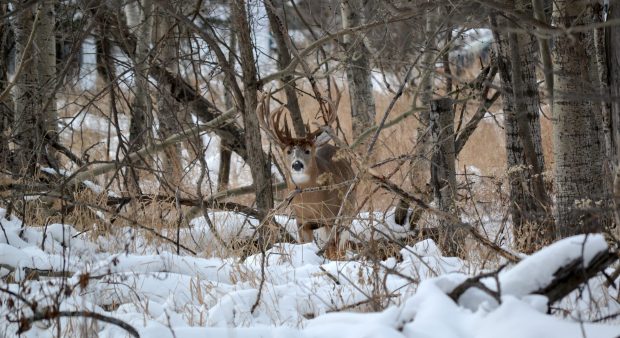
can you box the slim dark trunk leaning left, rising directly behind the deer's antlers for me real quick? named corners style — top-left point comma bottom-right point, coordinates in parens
top-left (263, 0), bottom-right (306, 137)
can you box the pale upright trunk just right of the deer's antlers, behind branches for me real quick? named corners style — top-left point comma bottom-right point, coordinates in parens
top-left (340, 0), bottom-right (375, 139)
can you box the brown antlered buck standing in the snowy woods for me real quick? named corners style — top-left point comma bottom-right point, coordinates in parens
top-left (257, 94), bottom-right (355, 257)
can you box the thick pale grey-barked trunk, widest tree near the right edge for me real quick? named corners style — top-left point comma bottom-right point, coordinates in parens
top-left (553, 0), bottom-right (608, 237)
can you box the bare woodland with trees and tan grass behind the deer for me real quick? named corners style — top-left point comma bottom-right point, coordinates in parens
top-left (0, 0), bottom-right (620, 255)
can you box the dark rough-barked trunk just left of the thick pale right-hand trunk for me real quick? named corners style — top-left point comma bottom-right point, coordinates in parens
top-left (491, 7), bottom-right (555, 252)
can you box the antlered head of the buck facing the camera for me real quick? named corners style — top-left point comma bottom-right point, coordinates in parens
top-left (258, 92), bottom-right (340, 186)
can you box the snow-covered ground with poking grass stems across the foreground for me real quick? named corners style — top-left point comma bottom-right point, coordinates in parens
top-left (0, 209), bottom-right (620, 338)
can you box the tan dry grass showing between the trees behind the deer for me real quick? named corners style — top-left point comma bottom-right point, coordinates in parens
top-left (4, 68), bottom-right (553, 258)
